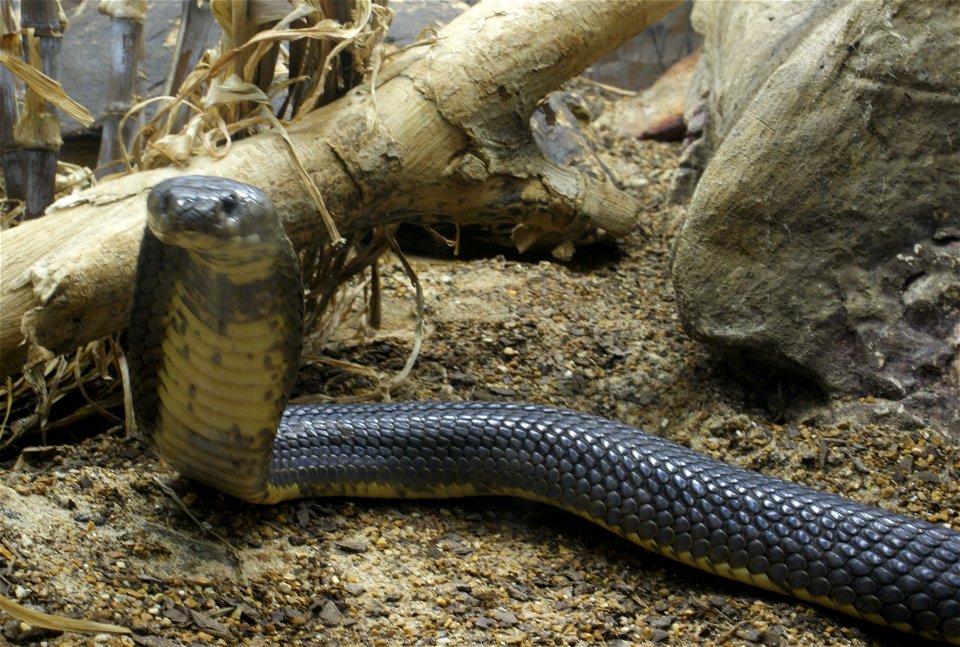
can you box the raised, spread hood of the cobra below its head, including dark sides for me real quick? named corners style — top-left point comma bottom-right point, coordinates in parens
top-left (131, 232), bottom-right (303, 502)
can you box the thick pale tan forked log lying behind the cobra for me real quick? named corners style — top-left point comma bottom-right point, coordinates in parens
top-left (0, 0), bottom-right (679, 376)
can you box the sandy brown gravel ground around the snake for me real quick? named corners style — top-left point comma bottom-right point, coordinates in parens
top-left (0, 104), bottom-right (960, 646)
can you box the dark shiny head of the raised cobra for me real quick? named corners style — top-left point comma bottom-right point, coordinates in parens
top-left (147, 175), bottom-right (282, 252)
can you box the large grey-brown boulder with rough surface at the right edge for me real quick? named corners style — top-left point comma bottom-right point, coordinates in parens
top-left (673, 0), bottom-right (960, 423)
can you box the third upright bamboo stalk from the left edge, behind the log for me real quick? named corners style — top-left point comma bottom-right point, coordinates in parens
top-left (97, 0), bottom-right (147, 177)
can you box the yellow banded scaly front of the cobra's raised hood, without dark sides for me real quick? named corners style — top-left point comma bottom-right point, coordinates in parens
top-left (151, 283), bottom-right (286, 501)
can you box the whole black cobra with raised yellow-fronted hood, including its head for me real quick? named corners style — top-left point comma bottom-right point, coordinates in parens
top-left (127, 177), bottom-right (960, 644)
